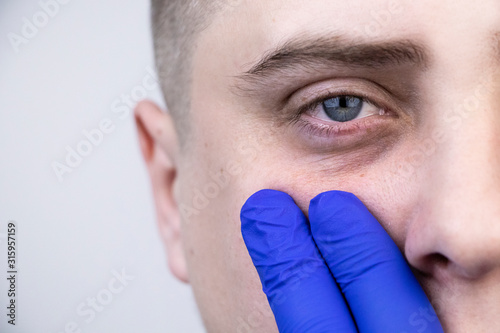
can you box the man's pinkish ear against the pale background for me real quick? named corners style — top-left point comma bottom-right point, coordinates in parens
top-left (134, 101), bottom-right (188, 282)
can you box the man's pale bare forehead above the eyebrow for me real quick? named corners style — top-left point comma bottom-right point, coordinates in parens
top-left (194, 0), bottom-right (500, 74)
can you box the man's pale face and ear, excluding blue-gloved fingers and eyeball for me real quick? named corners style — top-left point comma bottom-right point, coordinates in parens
top-left (136, 0), bottom-right (500, 333)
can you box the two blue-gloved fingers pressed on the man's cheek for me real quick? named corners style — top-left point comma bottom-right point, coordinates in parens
top-left (241, 190), bottom-right (443, 333)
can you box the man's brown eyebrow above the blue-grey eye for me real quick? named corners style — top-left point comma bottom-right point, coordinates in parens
top-left (239, 36), bottom-right (429, 81)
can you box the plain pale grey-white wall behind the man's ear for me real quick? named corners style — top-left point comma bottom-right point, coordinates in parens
top-left (0, 0), bottom-right (203, 333)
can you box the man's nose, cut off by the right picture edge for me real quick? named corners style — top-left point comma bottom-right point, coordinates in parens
top-left (405, 81), bottom-right (500, 279)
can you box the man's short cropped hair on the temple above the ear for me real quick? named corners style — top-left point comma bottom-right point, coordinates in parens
top-left (151, 0), bottom-right (224, 141)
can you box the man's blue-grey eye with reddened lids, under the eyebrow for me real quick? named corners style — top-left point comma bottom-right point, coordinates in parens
top-left (291, 80), bottom-right (401, 145)
